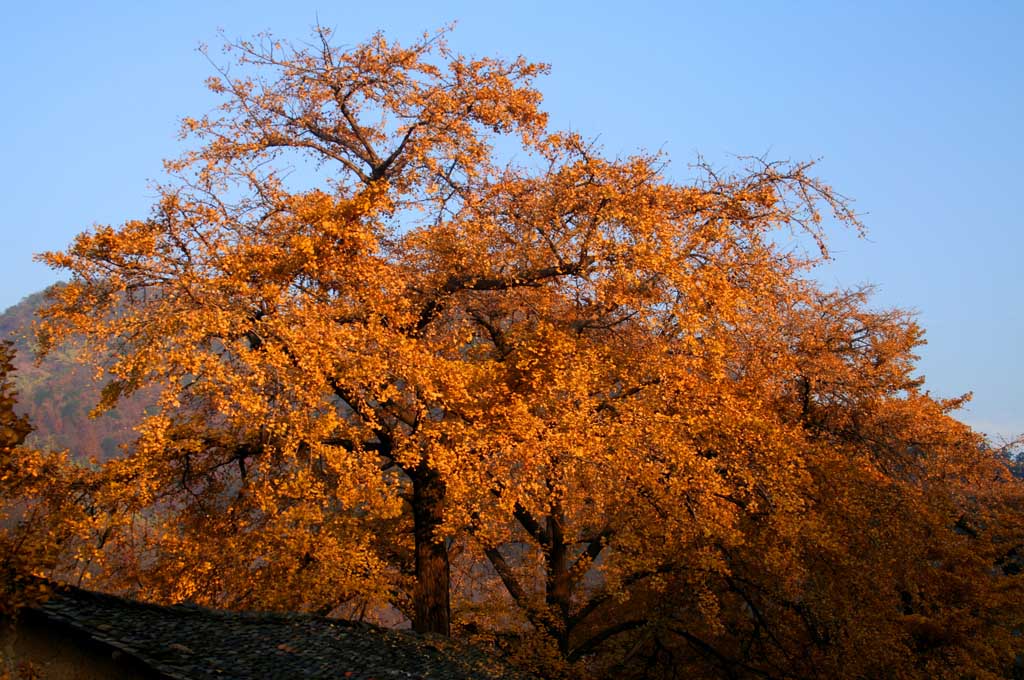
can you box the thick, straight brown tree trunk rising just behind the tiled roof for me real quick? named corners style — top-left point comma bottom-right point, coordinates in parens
top-left (412, 463), bottom-right (452, 636)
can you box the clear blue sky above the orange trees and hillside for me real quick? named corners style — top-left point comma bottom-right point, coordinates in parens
top-left (0, 0), bottom-right (1024, 435)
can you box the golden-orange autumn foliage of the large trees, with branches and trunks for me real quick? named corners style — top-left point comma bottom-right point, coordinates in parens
top-left (4, 29), bottom-right (1024, 678)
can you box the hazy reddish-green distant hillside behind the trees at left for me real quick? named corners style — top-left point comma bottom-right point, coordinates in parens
top-left (0, 292), bottom-right (143, 461)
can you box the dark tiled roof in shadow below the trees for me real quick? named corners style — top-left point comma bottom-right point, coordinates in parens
top-left (33, 587), bottom-right (526, 680)
